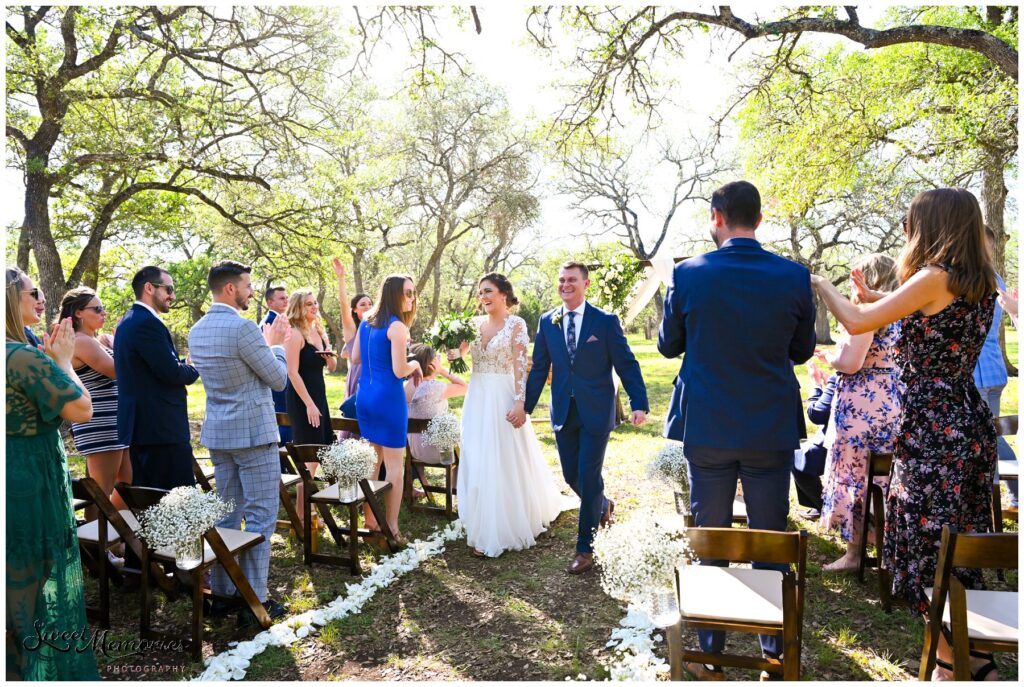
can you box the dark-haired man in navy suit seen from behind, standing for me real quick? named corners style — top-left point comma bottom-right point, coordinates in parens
top-left (657, 181), bottom-right (814, 679)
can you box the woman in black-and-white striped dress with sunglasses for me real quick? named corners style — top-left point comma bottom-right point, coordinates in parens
top-left (60, 287), bottom-right (131, 509)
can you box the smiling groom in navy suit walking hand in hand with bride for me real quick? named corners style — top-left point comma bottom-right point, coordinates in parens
top-left (525, 262), bottom-right (648, 574)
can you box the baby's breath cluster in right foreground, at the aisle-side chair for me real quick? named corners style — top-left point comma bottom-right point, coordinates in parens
top-left (594, 511), bottom-right (695, 603)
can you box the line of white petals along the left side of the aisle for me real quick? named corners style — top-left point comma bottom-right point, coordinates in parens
top-left (194, 520), bottom-right (466, 682)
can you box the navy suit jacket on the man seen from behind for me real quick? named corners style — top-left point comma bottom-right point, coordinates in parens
top-left (657, 239), bottom-right (815, 450)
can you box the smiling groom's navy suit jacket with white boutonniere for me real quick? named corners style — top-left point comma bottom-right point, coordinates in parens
top-left (525, 303), bottom-right (649, 433)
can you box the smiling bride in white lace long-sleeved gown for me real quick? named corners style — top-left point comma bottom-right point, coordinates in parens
top-left (458, 272), bottom-right (564, 557)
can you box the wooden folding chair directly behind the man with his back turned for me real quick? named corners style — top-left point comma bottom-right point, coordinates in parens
top-left (667, 527), bottom-right (807, 681)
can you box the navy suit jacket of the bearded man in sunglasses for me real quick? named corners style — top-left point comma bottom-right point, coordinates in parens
top-left (114, 304), bottom-right (199, 445)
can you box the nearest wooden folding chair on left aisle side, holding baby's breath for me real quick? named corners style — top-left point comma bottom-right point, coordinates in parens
top-left (115, 482), bottom-right (270, 661)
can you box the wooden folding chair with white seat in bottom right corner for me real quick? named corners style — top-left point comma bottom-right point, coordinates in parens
top-left (919, 525), bottom-right (1019, 682)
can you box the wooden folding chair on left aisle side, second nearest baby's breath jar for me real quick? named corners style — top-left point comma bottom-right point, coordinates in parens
top-left (288, 443), bottom-right (398, 575)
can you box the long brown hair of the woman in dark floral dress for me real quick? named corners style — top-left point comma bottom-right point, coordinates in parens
top-left (899, 188), bottom-right (995, 303)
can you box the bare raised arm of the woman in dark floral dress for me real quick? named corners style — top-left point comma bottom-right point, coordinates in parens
top-left (811, 266), bottom-right (952, 334)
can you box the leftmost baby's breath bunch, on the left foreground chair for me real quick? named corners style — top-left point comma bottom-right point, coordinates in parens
top-left (138, 486), bottom-right (234, 567)
